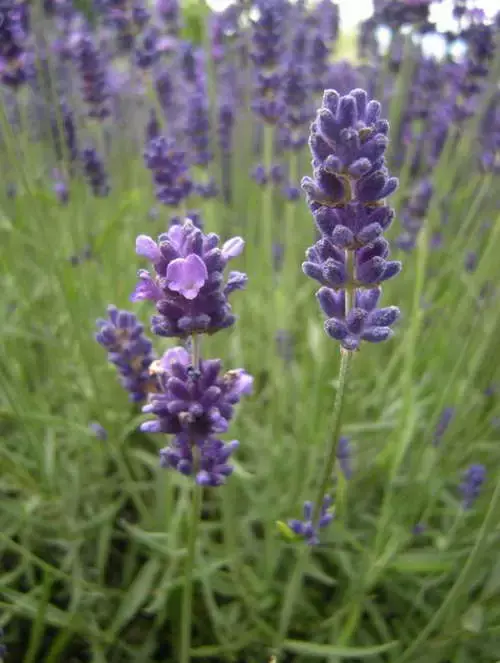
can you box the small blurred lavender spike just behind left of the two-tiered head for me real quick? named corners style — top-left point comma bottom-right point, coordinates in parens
top-left (95, 306), bottom-right (156, 403)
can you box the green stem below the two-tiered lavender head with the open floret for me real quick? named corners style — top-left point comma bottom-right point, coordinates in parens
top-left (179, 484), bottom-right (203, 663)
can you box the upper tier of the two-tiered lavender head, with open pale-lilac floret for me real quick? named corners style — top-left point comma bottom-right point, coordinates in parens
top-left (131, 219), bottom-right (247, 338)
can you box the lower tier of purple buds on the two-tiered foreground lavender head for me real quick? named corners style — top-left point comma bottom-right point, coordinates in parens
top-left (141, 347), bottom-right (253, 486)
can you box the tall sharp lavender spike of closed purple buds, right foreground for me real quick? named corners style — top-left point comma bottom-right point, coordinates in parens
top-left (302, 89), bottom-right (401, 351)
